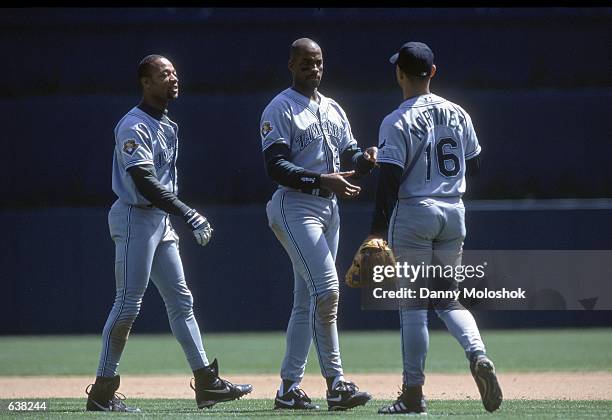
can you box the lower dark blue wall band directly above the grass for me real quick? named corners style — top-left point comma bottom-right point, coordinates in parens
top-left (0, 200), bottom-right (612, 334)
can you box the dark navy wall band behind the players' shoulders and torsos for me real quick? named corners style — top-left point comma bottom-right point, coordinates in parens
top-left (0, 89), bottom-right (612, 207)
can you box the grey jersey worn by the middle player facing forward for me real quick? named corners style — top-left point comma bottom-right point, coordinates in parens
top-left (260, 88), bottom-right (357, 174)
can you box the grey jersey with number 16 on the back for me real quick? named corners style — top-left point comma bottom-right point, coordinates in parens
top-left (377, 94), bottom-right (480, 198)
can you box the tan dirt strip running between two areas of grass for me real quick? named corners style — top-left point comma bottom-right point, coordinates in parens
top-left (0, 372), bottom-right (612, 400)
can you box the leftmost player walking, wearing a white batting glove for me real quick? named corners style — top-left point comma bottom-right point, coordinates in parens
top-left (86, 55), bottom-right (252, 412)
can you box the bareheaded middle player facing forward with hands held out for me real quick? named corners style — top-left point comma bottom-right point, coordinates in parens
top-left (260, 38), bottom-right (377, 410)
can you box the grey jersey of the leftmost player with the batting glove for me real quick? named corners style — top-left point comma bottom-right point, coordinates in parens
top-left (113, 107), bottom-right (178, 205)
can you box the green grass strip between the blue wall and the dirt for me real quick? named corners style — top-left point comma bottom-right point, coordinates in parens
top-left (0, 329), bottom-right (612, 376)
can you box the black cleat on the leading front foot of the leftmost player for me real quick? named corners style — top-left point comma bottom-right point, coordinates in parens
top-left (189, 359), bottom-right (253, 408)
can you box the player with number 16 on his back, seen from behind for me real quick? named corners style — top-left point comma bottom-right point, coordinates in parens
top-left (370, 42), bottom-right (502, 414)
